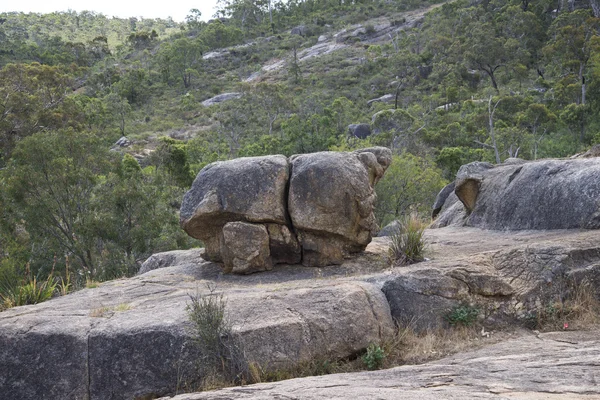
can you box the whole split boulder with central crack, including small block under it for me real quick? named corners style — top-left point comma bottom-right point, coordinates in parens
top-left (180, 147), bottom-right (391, 274)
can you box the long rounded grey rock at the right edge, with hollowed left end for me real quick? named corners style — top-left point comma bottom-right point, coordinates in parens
top-left (434, 158), bottom-right (600, 230)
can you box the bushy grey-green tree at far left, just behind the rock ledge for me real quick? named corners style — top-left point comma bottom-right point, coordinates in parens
top-left (3, 130), bottom-right (111, 277)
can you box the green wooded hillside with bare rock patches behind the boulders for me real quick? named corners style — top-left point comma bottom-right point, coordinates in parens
top-left (0, 0), bottom-right (600, 296)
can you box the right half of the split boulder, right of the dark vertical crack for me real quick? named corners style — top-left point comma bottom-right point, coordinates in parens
top-left (288, 148), bottom-right (391, 266)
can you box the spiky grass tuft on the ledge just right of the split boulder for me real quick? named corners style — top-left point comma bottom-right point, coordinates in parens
top-left (390, 215), bottom-right (426, 265)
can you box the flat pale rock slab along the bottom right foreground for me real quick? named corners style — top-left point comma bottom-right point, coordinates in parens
top-left (165, 331), bottom-right (600, 400)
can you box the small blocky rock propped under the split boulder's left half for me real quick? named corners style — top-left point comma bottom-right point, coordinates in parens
top-left (221, 222), bottom-right (273, 274)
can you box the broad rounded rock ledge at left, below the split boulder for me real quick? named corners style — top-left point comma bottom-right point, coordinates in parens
top-left (0, 250), bottom-right (394, 400)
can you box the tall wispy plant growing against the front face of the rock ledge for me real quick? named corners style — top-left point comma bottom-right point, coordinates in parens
top-left (187, 288), bottom-right (251, 389)
